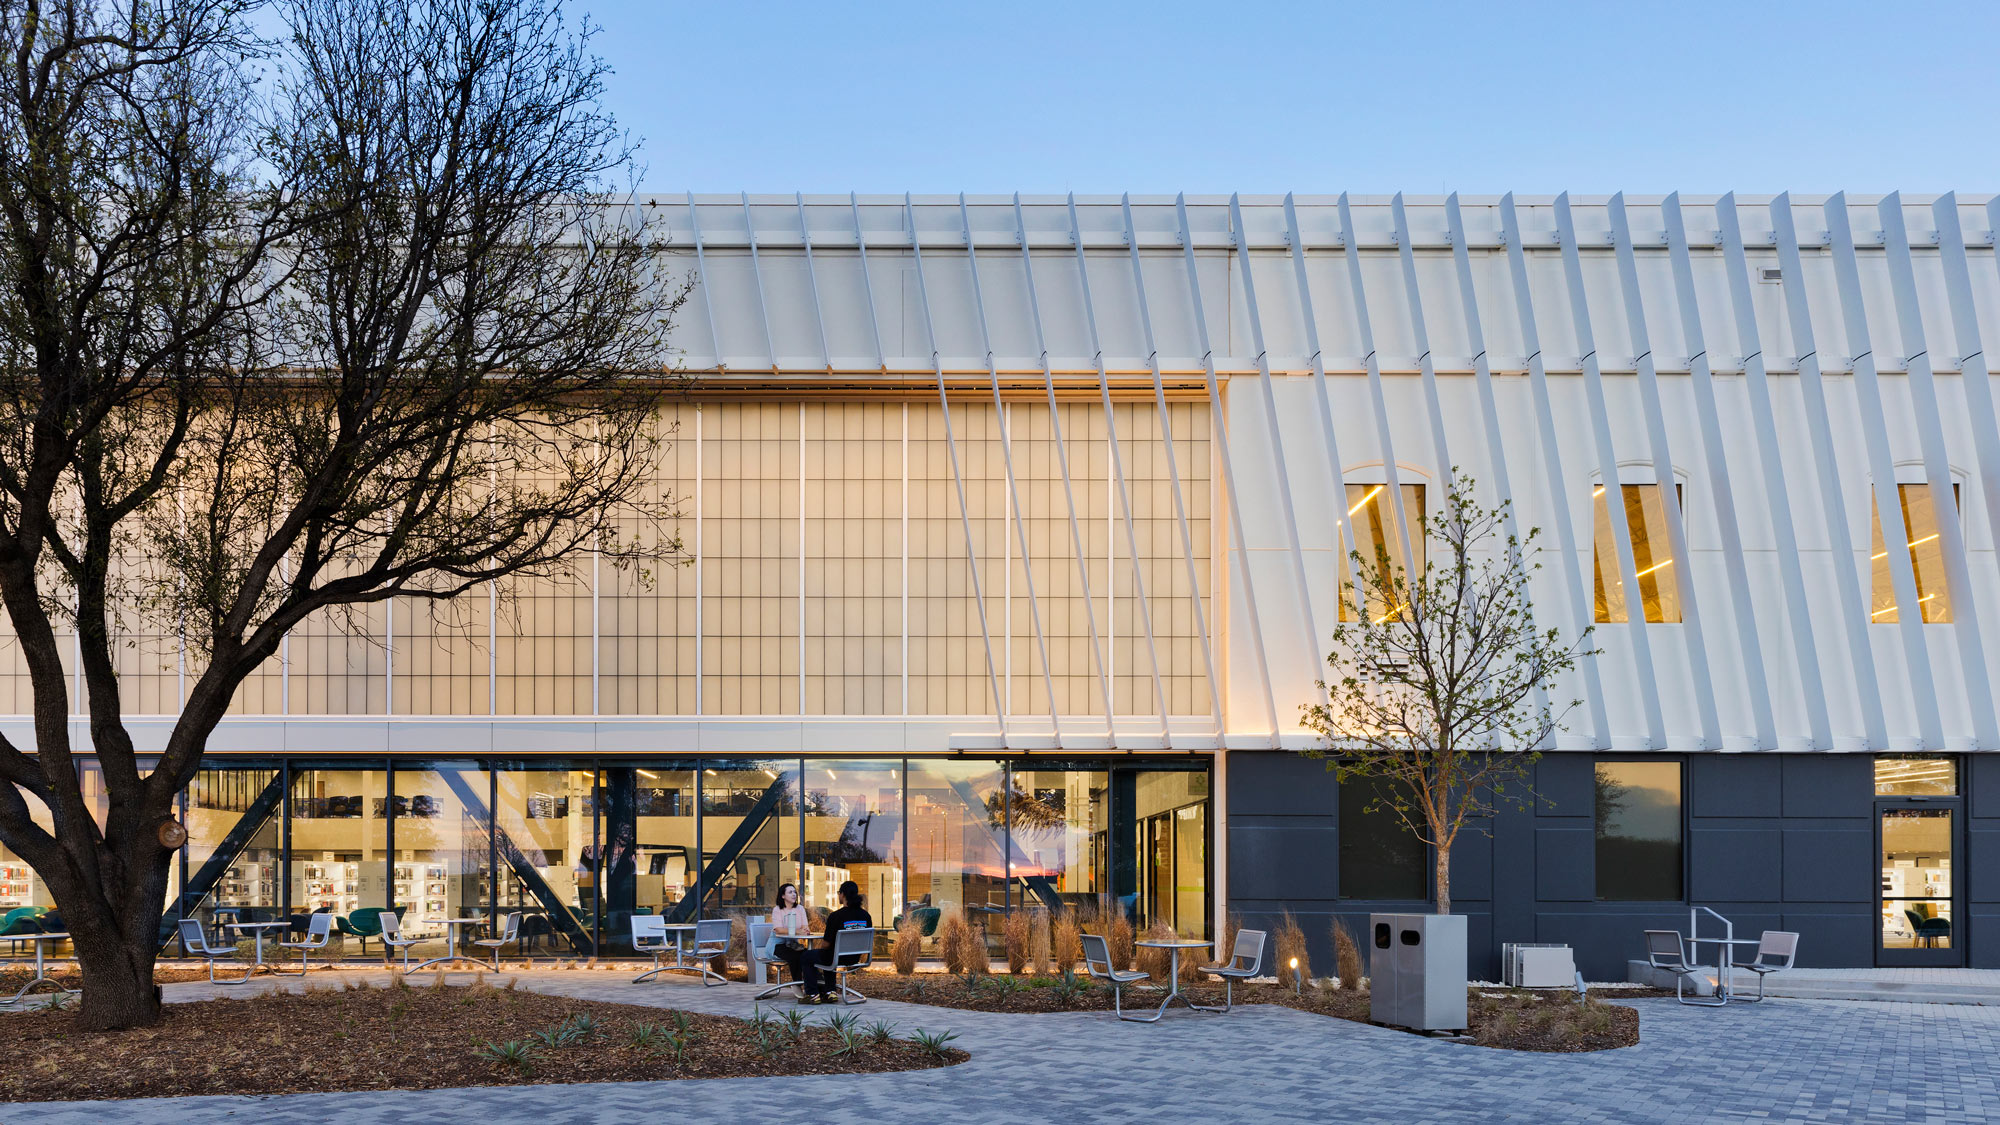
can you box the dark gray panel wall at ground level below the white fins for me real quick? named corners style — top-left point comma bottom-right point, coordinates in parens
top-left (1228, 751), bottom-right (2000, 979)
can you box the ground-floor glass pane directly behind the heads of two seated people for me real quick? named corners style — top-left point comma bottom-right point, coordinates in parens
top-left (800, 759), bottom-right (902, 925)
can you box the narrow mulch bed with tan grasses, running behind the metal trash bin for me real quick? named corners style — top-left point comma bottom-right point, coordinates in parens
top-left (850, 973), bottom-right (1658, 1053)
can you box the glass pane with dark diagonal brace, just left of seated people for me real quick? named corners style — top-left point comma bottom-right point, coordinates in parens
top-left (702, 759), bottom-right (798, 917)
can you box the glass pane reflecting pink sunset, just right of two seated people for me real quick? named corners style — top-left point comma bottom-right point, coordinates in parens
top-left (908, 759), bottom-right (1006, 924)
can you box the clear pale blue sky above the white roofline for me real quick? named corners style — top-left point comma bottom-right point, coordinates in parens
top-left (576, 0), bottom-right (2000, 192)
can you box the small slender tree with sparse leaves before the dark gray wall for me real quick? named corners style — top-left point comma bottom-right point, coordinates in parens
top-left (1302, 474), bottom-right (1590, 915)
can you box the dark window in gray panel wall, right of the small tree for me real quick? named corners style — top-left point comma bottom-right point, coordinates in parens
top-left (1596, 763), bottom-right (1682, 903)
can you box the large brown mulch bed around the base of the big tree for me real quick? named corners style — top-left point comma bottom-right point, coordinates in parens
top-left (0, 973), bottom-right (968, 1103)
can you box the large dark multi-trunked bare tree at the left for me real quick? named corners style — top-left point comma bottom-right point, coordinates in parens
top-left (0, 0), bottom-right (686, 1027)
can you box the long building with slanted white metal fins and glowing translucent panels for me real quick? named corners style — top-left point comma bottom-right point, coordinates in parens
top-left (0, 194), bottom-right (2000, 971)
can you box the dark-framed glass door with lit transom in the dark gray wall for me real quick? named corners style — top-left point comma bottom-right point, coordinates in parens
top-left (1876, 757), bottom-right (1966, 965)
